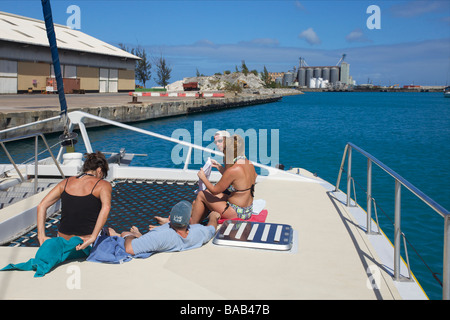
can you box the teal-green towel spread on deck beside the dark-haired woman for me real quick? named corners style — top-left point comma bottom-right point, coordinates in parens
top-left (0, 237), bottom-right (91, 278)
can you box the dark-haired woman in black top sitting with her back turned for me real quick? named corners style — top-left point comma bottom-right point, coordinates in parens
top-left (37, 151), bottom-right (112, 250)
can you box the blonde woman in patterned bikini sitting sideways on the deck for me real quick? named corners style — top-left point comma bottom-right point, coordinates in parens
top-left (191, 135), bottom-right (257, 224)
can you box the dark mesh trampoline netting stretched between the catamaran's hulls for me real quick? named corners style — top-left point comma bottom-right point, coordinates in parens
top-left (7, 180), bottom-right (198, 247)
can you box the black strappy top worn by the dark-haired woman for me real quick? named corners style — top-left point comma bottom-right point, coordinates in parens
top-left (58, 174), bottom-right (102, 236)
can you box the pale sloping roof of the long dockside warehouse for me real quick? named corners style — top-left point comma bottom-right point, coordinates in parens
top-left (0, 11), bottom-right (140, 60)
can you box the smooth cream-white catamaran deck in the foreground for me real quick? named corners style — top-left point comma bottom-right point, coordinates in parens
top-left (0, 170), bottom-right (427, 300)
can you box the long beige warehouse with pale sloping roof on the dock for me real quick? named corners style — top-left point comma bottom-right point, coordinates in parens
top-left (0, 12), bottom-right (140, 94)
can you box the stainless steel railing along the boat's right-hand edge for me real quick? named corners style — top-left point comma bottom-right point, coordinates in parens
top-left (335, 142), bottom-right (450, 300)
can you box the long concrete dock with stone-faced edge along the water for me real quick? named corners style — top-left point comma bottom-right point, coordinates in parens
top-left (0, 93), bottom-right (288, 139)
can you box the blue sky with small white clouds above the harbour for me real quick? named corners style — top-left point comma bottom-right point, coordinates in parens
top-left (0, 0), bottom-right (450, 85)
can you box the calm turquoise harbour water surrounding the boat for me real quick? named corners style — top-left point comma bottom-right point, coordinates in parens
top-left (1, 92), bottom-right (450, 299)
